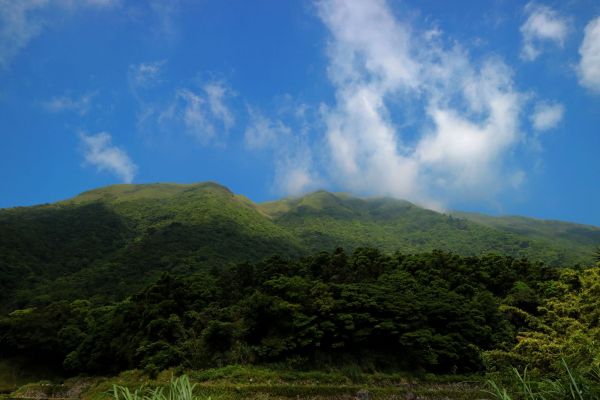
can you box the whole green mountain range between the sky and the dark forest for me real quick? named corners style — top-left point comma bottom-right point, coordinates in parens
top-left (0, 183), bottom-right (600, 308)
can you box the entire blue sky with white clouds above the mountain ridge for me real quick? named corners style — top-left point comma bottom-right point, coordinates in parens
top-left (0, 0), bottom-right (600, 226)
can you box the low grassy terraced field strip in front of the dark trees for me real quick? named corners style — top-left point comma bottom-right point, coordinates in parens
top-left (8, 366), bottom-right (492, 400)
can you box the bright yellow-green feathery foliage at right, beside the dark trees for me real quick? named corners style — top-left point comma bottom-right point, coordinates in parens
top-left (487, 267), bottom-right (600, 373)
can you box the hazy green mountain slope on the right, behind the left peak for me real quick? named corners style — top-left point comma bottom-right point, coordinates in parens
top-left (260, 192), bottom-right (600, 265)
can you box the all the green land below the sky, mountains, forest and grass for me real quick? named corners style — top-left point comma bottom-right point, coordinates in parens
top-left (0, 184), bottom-right (600, 400)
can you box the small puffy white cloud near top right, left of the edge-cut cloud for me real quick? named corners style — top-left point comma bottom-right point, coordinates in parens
top-left (521, 3), bottom-right (568, 61)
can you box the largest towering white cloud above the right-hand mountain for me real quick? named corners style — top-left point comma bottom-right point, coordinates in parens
top-left (317, 0), bottom-right (527, 208)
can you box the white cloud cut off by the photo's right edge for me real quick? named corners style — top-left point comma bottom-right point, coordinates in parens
top-left (578, 17), bottom-right (600, 93)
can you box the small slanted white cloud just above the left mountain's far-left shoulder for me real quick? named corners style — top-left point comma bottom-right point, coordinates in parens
top-left (80, 132), bottom-right (137, 183)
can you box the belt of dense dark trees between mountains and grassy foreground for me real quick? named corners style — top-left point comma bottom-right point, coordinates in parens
top-left (0, 248), bottom-right (600, 384)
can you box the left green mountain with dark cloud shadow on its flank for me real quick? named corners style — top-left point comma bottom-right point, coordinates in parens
top-left (0, 183), bottom-right (304, 305)
